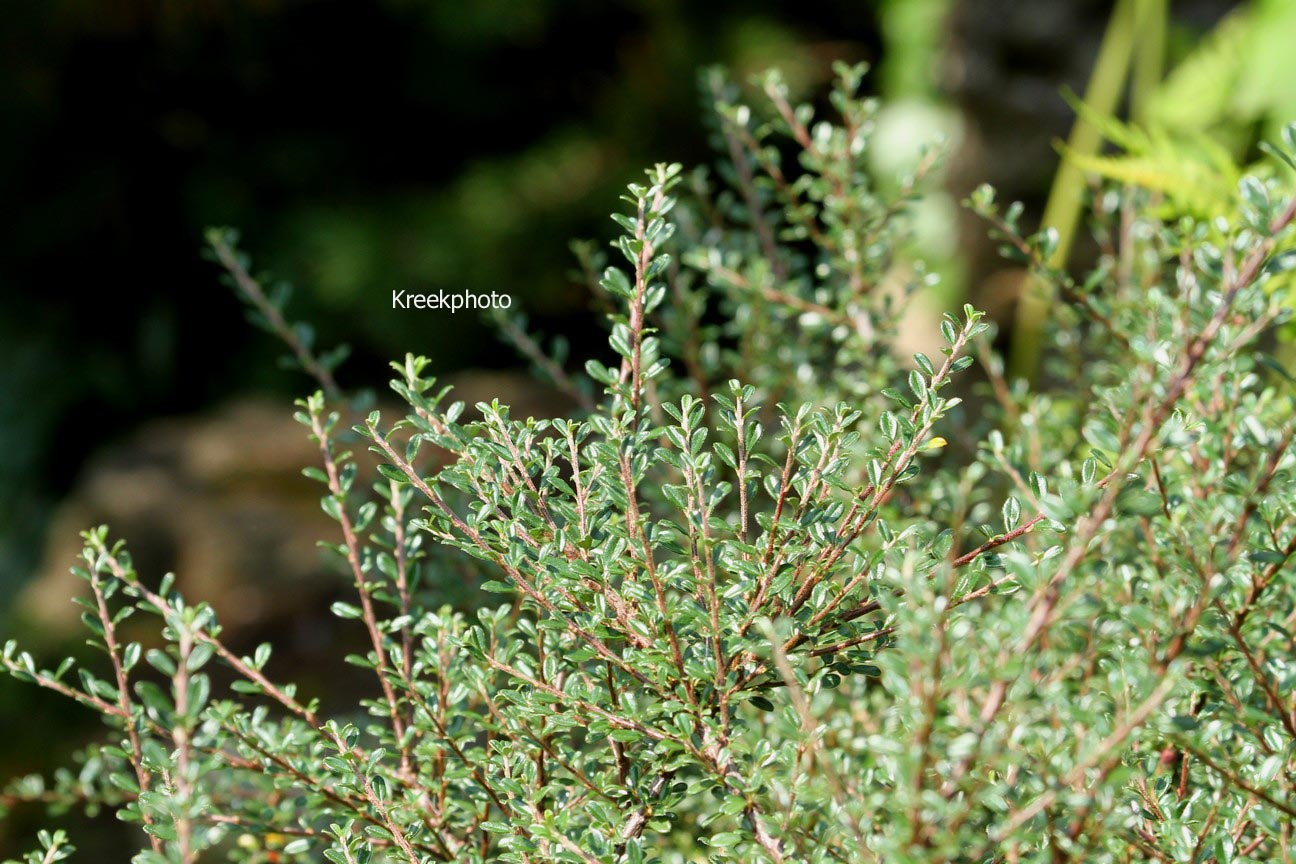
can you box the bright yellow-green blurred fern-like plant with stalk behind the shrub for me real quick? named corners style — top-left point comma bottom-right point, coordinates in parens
top-left (1010, 0), bottom-right (1296, 380)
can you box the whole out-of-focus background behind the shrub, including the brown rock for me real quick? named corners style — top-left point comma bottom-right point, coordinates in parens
top-left (0, 0), bottom-right (1275, 861)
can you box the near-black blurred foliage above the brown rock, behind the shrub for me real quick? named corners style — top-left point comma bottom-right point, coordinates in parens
top-left (0, 0), bottom-right (877, 595)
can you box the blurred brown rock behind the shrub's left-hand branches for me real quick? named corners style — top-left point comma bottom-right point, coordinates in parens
top-left (16, 372), bottom-right (570, 647)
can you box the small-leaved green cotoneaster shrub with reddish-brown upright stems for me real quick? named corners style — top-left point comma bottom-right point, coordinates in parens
top-left (3, 69), bottom-right (1296, 864)
